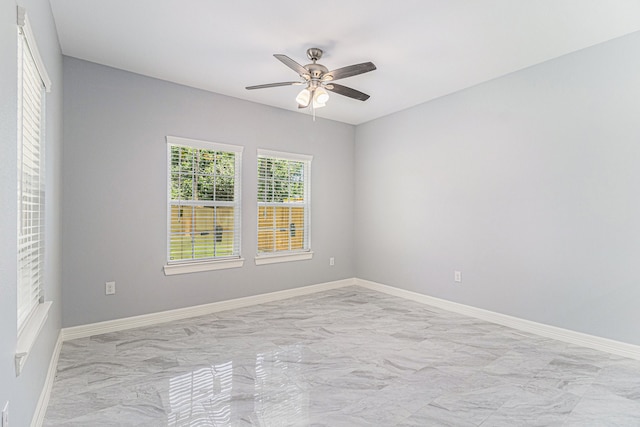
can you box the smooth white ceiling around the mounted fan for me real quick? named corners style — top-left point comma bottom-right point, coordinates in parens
top-left (50, 0), bottom-right (640, 124)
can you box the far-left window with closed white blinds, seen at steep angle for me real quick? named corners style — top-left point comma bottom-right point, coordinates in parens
top-left (15, 6), bottom-right (52, 376)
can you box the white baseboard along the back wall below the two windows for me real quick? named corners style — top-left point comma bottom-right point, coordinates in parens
top-left (62, 279), bottom-right (356, 341)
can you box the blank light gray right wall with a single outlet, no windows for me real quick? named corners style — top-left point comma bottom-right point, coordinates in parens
top-left (354, 33), bottom-right (640, 344)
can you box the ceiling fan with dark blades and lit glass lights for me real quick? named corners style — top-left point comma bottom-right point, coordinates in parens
top-left (246, 47), bottom-right (376, 108)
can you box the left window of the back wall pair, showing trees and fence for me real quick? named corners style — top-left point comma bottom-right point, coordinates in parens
top-left (165, 136), bottom-right (243, 274)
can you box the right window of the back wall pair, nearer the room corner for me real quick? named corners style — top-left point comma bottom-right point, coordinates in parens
top-left (256, 150), bottom-right (312, 264)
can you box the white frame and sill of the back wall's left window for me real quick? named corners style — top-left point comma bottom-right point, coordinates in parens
top-left (164, 136), bottom-right (244, 276)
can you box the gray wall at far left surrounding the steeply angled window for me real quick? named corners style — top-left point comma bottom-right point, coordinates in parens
top-left (0, 0), bottom-right (62, 426)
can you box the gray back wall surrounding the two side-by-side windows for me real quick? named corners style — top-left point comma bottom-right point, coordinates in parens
top-left (63, 57), bottom-right (355, 327)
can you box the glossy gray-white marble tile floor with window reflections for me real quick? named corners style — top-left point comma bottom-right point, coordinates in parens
top-left (44, 286), bottom-right (640, 427)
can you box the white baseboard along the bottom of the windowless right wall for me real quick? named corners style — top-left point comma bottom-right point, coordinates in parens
top-left (356, 279), bottom-right (640, 360)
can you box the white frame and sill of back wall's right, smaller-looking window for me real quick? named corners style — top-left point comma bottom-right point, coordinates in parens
top-left (255, 149), bottom-right (313, 265)
